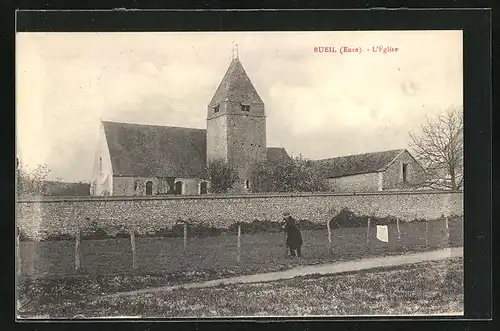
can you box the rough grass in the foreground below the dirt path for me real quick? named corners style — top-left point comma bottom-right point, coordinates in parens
top-left (20, 258), bottom-right (464, 318)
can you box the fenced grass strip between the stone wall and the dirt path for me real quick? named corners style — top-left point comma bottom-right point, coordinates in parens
top-left (20, 220), bottom-right (462, 277)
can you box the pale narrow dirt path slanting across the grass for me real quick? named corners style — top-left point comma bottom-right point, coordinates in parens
top-left (108, 247), bottom-right (463, 297)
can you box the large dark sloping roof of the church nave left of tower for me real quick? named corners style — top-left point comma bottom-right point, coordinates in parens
top-left (102, 121), bottom-right (206, 178)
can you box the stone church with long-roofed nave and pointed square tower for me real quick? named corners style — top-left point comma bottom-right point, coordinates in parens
top-left (91, 56), bottom-right (289, 196)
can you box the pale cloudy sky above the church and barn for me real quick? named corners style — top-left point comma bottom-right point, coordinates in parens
top-left (16, 31), bottom-right (463, 181)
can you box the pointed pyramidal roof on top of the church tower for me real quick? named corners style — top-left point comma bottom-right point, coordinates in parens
top-left (210, 57), bottom-right (264, 106)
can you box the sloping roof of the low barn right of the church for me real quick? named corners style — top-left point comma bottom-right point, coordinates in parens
top-left (315, 149), bottom-right (405, 178)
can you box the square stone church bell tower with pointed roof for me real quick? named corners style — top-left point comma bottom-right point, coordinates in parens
top-left (207, 46), bottom-right (267, 193)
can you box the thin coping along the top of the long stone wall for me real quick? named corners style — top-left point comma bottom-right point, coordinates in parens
top-left (16, 190), bottom-right (464, 203)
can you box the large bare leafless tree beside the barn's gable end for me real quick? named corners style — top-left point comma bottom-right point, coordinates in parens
top-left (410, 107), bottom-right (464, 190)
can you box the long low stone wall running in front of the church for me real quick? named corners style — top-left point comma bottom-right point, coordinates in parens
top-left (16, 191), bottom-right (463, 238)
